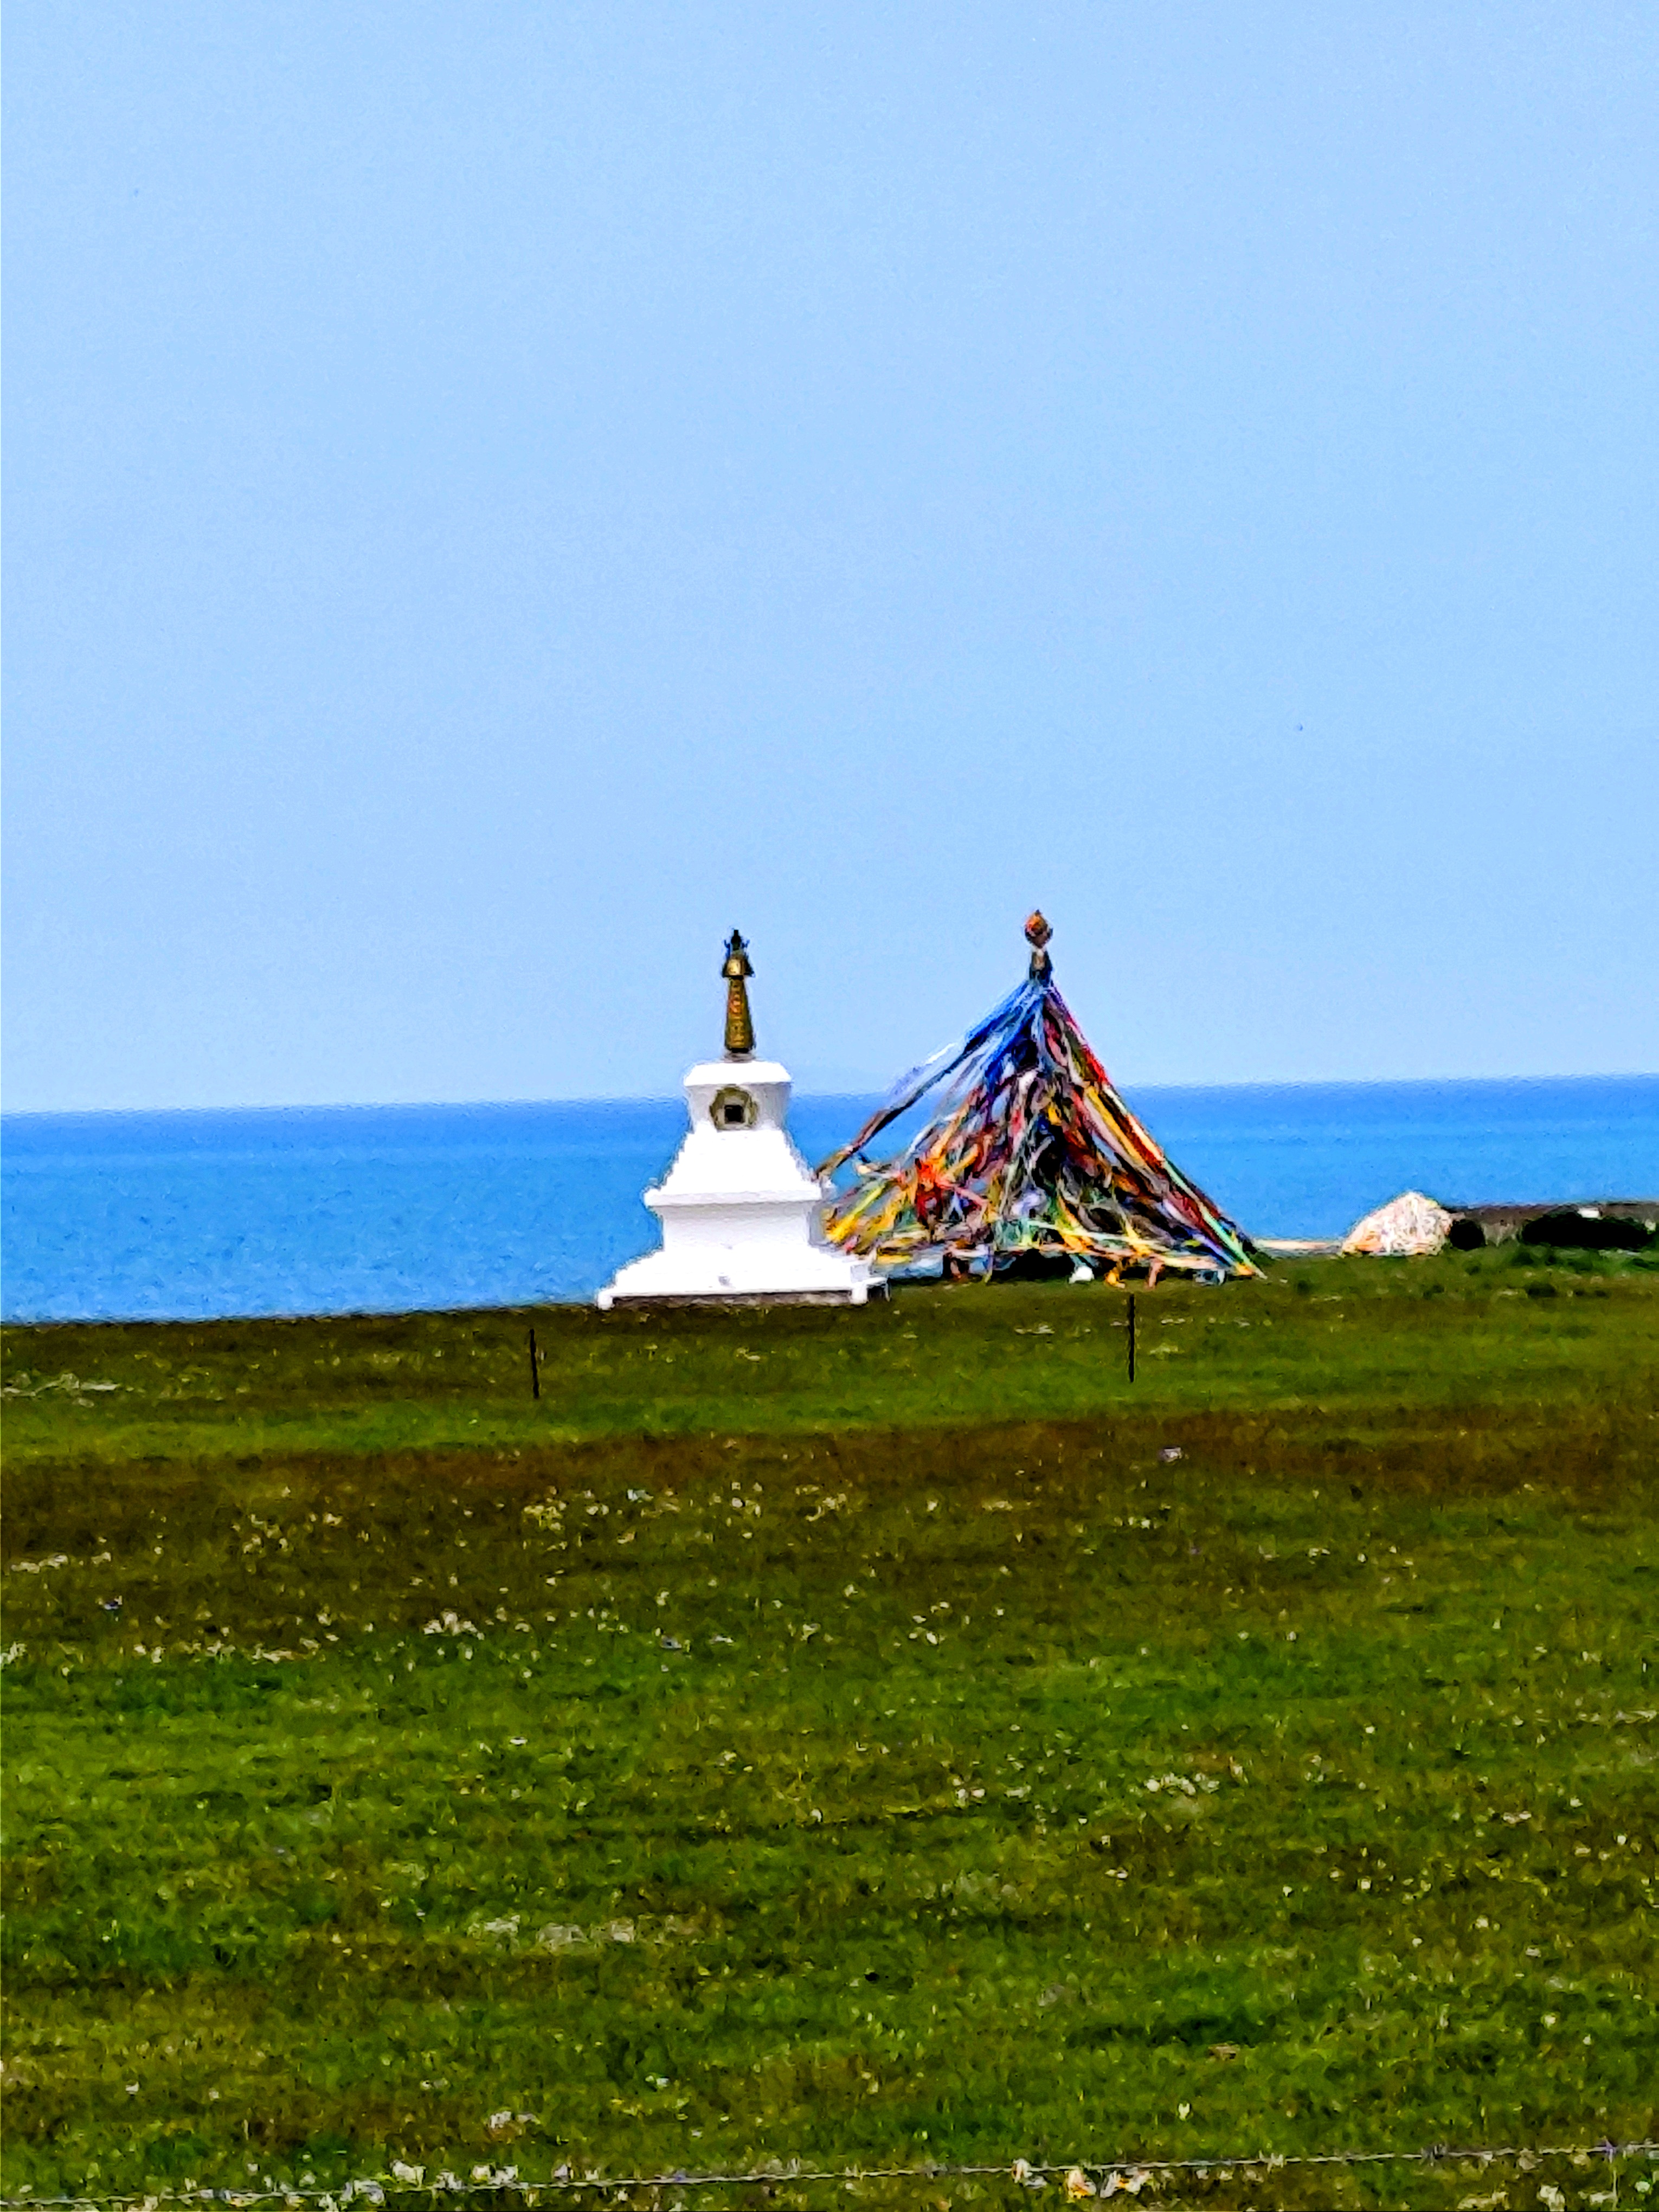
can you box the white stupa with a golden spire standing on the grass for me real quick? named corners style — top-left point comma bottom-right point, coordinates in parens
top-left (595, 931), bottom-right (885, 1311)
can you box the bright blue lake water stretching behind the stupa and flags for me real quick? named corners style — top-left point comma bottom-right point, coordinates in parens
top-left (0, 1075), bottom-right (1659, 1321)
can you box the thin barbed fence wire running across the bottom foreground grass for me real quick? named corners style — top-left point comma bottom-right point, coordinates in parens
top-left (0, 2137), bottom-right (1659, 2212)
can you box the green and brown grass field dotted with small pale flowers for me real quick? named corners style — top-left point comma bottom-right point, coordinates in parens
top-left (2, 1248), bottom-right (1659, 2208)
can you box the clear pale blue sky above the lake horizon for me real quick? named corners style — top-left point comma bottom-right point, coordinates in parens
top-left (7, 0), bottom-right (1659, 1108)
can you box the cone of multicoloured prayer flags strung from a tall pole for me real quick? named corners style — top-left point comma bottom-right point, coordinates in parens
top-left (819, 914), bottom-right (1259, 1283)
